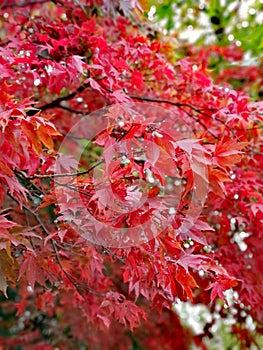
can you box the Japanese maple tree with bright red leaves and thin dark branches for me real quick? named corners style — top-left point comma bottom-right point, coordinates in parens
top-left (0, 0), bottom-right (263, 349)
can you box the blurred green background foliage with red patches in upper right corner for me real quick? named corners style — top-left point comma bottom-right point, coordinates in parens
top-left (146, 0), bottom-right (263, 100)
